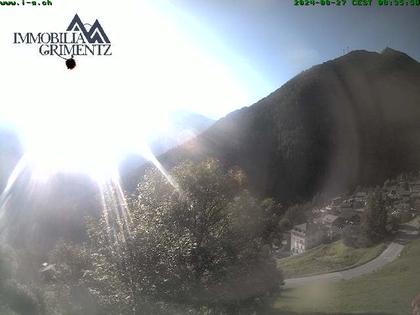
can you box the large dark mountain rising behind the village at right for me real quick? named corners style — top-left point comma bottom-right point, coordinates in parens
top-left (136, 48), bottom-right (420, 202)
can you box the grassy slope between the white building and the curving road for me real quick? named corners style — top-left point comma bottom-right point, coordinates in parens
top-left (277, 241), bottom-right (386, 278)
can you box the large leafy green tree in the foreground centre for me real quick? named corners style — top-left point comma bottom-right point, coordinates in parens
top-left (88, 160), bottom-right (282, 314)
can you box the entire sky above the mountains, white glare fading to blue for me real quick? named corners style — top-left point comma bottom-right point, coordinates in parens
top-left (0, 0), bottom-right (420, 178)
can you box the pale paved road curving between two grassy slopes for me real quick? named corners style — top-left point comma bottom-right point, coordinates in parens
top-left (285, 240), bottom-right (404, 288)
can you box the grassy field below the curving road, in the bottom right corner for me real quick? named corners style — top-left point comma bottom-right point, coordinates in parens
top-left (268, 241), bottom-right (420, 315)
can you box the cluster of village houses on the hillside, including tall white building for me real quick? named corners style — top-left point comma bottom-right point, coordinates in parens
top-left (282, 173), bottom-right (420, 255)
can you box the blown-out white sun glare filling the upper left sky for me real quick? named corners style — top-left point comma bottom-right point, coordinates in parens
top-left (0, 1), bottom-right (251, 184)
